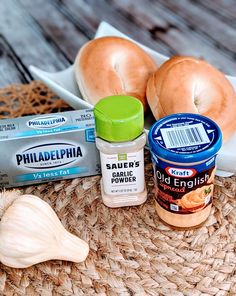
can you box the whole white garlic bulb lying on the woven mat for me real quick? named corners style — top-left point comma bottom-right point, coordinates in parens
top-left (0, 191), bottom-right (89, 268)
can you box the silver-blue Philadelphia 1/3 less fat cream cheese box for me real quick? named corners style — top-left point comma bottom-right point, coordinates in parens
top-left (0, 109), bottom-right (100, 187)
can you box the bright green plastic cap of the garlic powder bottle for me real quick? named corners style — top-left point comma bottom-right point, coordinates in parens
top-left (94, 95), bottom-right (144, 142)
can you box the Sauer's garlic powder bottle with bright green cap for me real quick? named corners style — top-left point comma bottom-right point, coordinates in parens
top-left (94, 95), bottom-right (147, 208)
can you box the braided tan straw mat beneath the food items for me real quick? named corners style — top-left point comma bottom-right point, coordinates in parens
top-left (0, 82), bottom-right (236, 296)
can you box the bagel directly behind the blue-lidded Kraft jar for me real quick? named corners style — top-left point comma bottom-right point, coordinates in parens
top-left (147, 57), bottom-right (236, 140)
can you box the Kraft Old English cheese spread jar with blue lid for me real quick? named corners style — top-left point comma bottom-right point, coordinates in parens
top-left (148, 113), bottom-right (222, 228)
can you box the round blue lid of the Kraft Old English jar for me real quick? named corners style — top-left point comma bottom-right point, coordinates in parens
top-left (148, 113), bottom-right (222, 163)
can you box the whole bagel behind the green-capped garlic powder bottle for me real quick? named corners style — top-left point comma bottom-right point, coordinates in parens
top-left (75, 37), bottom-right (157, 110)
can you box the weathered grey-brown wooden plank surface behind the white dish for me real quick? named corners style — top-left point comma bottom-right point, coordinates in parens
top-left (0, 0), bottom-right (236, 87)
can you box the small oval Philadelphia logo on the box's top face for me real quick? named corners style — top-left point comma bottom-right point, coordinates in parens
top-left (26, 115), bottom-right (67, 129)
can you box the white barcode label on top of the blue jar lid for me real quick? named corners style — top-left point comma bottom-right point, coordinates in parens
top-left (161, 123), bottom-right (210, 148)
